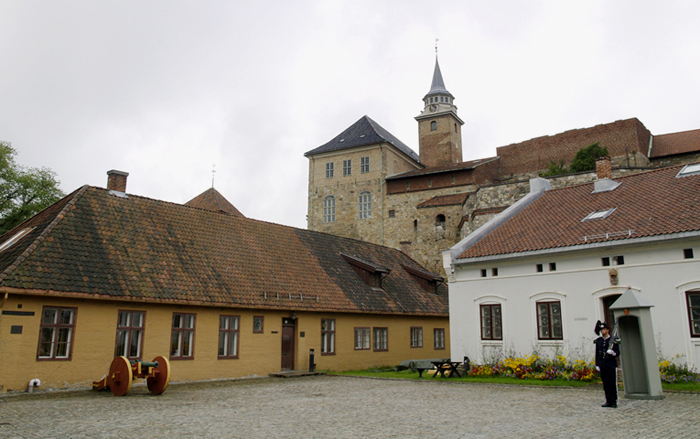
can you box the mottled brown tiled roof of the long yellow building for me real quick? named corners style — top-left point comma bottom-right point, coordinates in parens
top-left (0, 186), bottom-right (448, 316)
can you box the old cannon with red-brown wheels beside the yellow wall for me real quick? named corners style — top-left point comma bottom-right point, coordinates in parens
top-left (92, 357), bottom-right (170, 396)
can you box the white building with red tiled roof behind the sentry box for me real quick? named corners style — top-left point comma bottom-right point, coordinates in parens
top-left (443, 160), bottom-right (700, 368)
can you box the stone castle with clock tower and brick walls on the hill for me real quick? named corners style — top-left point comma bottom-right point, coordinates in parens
top-left (305, 60), bottom-right (700, 276)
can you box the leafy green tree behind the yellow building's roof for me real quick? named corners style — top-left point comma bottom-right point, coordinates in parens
top-left (0, 141), bottom-right (64, 234)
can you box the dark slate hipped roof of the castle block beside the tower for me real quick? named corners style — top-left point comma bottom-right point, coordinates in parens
top-left (304, 116), bottom-right (420, 163)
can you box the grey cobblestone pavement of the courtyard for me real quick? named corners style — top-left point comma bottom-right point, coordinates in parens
top-left (0, 376), bottom-right (700, 438)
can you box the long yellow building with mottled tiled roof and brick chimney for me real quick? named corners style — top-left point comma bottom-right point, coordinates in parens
top-left (0, 171), bottom-right (449, 392)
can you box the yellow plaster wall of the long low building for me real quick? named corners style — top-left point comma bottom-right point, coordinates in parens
top-left (0, 294), bottom-right (449, 392)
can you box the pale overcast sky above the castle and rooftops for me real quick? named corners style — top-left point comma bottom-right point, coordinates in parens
top-left (0, 0), bottom-right (700, 228)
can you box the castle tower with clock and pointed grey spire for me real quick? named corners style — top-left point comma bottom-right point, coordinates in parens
top-left (416, 56), bottom-right (464, 167)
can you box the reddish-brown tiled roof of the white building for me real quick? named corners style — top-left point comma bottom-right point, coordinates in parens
top-left (458, 166), bottom-right (700, 259)
